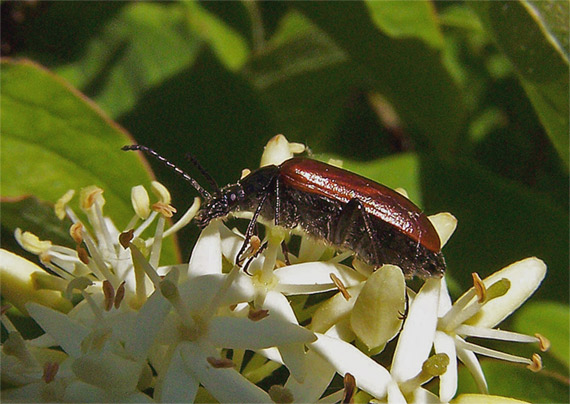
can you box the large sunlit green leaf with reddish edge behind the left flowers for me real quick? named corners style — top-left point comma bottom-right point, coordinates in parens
top-left (0, 60), bottom-right (178, 258)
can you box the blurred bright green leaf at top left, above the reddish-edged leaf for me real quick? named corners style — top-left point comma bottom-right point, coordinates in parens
top-left (54, 2), bottom-right (203, 117)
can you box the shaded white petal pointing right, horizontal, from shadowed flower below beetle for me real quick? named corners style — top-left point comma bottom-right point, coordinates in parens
top-left (208, 315), bottom-right (315, 349)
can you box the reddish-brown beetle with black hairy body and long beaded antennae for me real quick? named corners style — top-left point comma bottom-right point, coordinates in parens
top-left (123, 145), bottom-right (446, 278)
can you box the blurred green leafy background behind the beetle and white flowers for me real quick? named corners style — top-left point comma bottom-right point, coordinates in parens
top-left (1, 1), bottom-right (569, 399)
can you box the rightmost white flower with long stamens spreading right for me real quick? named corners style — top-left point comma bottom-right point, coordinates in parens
top-left (435, 258), bottom-right (548, 401)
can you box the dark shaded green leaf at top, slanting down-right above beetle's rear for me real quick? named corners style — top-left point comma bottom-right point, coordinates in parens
top-left (292, 2), bottom-right (466, 153)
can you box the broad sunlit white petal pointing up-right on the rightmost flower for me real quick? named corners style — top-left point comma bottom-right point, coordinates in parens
top-left (467, 257), bottom-right (546, 328)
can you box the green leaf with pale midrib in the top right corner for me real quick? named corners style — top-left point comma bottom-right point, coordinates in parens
top-left (469, 1), bottom-right (569, 167)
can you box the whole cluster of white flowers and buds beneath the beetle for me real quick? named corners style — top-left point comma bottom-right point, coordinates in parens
top-left (0, 136), bottom-right (547, 403)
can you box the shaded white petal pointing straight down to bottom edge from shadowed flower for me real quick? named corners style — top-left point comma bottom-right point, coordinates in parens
top-left (154, 345), bottom-right (200, 403)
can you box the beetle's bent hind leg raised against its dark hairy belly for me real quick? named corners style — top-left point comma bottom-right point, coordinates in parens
top-left (333, 198), bottom-right (380, 262)
